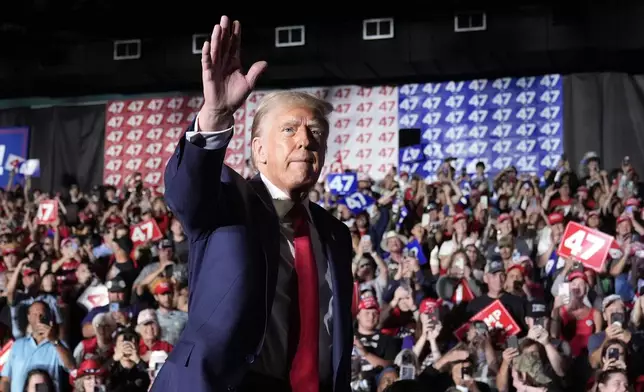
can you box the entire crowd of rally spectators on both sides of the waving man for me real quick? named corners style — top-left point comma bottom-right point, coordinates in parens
top-left (0, 149), bottom-right (644, 392)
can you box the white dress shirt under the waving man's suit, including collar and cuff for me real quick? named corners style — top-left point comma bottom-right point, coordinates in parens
top-left (186, 120), bottom-right (333, 381)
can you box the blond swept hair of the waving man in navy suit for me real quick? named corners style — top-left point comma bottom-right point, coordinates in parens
top-left (250, 91), bottom-right (333, 168)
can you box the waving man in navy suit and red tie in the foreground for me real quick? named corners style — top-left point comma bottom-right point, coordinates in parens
top-left (152, 16), bottom-right (353, 392)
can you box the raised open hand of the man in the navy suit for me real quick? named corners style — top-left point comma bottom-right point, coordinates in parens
top-left (199, 16), bottom-right (266, 131)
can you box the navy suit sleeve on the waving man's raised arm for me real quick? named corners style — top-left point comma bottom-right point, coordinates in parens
top-left (164, 120), bottom-right (233, 240)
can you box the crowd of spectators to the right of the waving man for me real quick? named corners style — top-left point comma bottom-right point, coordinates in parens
top-left (340, 153), bottom-right (644, 392)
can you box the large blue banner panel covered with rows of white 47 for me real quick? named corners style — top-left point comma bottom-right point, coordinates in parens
top-left (398, 75), bottom-right (563, 180)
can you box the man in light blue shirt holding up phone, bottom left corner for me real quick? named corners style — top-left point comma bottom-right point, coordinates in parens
top-left (1, 301), bottom-right (75, 392)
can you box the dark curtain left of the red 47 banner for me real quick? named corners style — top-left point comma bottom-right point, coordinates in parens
top-left (0, 105), bottom-right (105, 192)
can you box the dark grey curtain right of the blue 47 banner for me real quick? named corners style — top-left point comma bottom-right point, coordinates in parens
top-left (563, 73), bottom-right (644, 172)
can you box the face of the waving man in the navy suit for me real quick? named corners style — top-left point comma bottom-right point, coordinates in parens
top-left (253, 106), bottom-right (328, 196)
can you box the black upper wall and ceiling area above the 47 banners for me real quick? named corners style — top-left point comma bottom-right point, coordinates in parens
top-left (0, 0), bottom-right (644, 98)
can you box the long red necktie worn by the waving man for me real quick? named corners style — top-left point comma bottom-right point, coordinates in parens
top-left (290, 203), bottom-right (320, 392)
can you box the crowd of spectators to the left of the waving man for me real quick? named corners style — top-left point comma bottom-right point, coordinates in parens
top-left (0, 174), bottom-right (188, 392)
